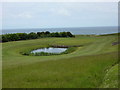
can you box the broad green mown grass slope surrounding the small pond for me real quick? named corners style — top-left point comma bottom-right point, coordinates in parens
top-left (3, 35), bottom-right (117, 88)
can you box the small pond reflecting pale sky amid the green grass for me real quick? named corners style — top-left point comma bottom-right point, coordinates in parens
top-left (31, 47), bottom-right (67, 53)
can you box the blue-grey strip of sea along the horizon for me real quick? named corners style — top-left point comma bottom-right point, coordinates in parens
top-left (2, 27), bottom-right (118, 35)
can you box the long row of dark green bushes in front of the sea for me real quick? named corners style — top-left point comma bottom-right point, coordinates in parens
top-left (2, 31), bottom-right (74, 42)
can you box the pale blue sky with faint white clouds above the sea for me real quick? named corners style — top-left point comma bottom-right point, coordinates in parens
top-left (0, 2), bottom-right (118, 29)
